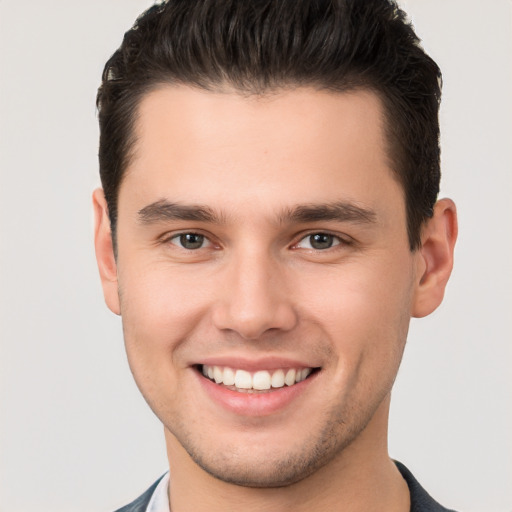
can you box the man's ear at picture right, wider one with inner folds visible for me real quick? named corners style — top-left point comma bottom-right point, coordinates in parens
top-left (411, 199), bottom-right (457, 318)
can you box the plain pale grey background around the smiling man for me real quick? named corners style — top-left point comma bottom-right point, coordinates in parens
top-left (0, 0), bottom-right (512, 512)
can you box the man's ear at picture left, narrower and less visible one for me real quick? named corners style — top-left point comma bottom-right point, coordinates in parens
top-left (92, 188), bottom-right (121, 315)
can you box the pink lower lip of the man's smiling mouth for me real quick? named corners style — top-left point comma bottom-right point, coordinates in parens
top-left (196, 372), bottom-right (318, 416)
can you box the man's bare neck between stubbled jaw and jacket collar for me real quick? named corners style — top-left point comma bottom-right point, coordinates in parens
top-left (165, 397), bottom-right (410, 512)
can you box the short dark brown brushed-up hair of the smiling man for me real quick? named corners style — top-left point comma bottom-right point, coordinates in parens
top-left (97, 0), bottom-right (441, 250)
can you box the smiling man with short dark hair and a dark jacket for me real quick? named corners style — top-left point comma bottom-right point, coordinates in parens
top-left (93, 0), bottom-right (457, 512)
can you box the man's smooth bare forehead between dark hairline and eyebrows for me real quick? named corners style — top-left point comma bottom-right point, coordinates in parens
top-left (120, 86), bottom-right (401, 220)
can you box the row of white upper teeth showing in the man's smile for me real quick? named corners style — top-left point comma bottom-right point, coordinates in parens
top-left (200, 364), bottom-right (314, 393)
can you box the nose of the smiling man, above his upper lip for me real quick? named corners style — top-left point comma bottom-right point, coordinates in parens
top-left (213, 249), bottom-right (297, 340)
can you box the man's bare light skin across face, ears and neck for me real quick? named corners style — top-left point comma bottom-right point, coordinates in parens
top-left (93, 86), bottom-right (457, 512)
